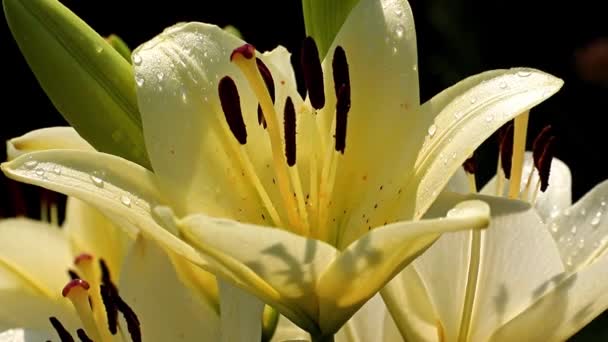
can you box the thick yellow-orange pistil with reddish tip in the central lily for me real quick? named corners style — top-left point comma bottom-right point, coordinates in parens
top-left (231, 50), bottom-right (304, 232)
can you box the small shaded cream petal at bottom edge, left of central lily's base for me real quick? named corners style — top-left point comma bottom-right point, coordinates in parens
top-left (218, 278), bottom-right (264, 342)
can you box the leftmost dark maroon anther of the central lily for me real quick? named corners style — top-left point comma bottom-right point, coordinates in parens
top-left (218, 76), bottom-right (247, 145)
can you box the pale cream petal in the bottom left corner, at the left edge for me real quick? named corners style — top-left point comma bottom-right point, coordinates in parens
top-left (0, 219), bottom-right (78, 332)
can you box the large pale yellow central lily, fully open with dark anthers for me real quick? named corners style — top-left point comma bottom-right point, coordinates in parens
top-left (2, 0), bottom-right (562, 338)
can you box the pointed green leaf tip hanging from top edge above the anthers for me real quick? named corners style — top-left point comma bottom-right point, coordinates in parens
top-left (302, 0), bottom-right (359, 59)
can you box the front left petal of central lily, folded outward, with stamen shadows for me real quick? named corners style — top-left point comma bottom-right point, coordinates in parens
top-left (180, 215), bottom-right (336, 331)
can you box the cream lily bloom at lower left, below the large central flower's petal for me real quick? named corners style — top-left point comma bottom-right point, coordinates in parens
top-left (0, 198), bottom-right (220, 342)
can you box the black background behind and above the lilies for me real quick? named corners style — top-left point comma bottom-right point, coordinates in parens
top-left (0, 0), bottom-right (608, 341)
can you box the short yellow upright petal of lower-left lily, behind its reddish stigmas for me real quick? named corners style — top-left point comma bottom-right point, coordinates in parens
top-left (63, 197), bottom-right (132, 275)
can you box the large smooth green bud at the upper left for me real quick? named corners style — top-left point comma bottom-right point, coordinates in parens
top-left (3, 0), bottom-right (150, 168)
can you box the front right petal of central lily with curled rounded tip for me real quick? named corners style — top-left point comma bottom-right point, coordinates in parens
top-left (317, 201), bottom-right (490, 333)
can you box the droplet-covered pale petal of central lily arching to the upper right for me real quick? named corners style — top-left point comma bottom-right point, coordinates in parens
top-left (410, 68), bottom-right (563, 217)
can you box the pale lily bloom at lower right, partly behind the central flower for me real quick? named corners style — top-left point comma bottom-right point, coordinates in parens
top-left (383, 148), bottom-right (608, 341)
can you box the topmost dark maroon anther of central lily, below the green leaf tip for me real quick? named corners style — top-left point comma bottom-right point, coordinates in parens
top-left (300, 37), bottom-right (325, 110)
